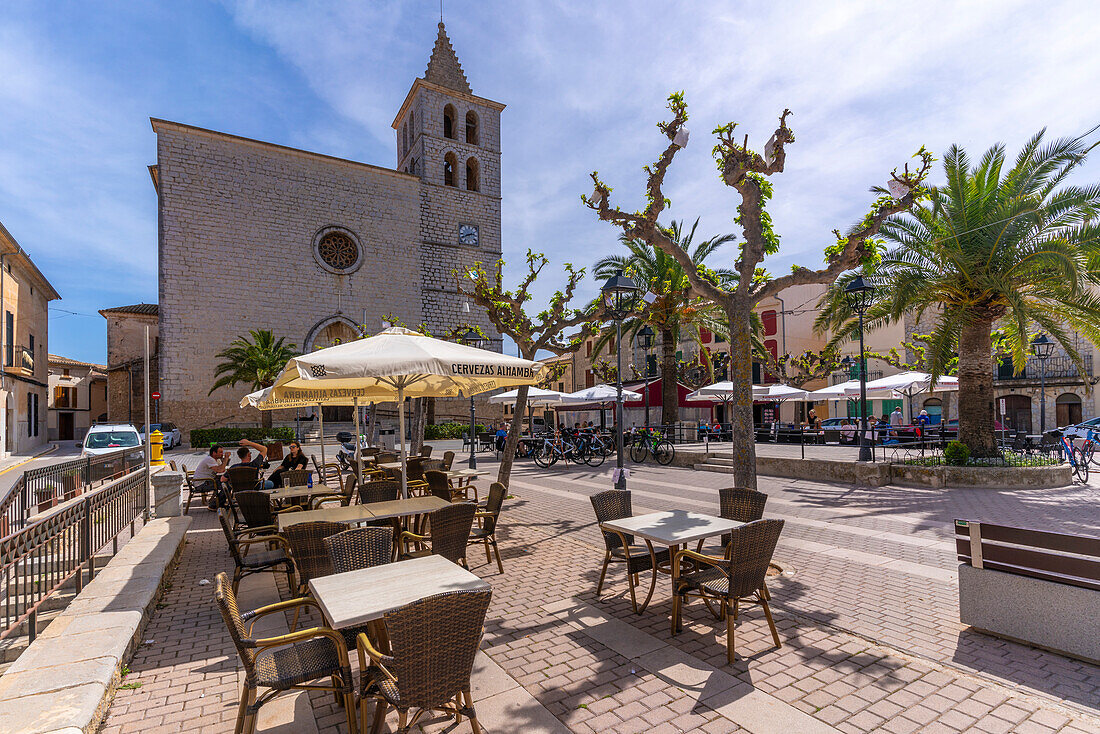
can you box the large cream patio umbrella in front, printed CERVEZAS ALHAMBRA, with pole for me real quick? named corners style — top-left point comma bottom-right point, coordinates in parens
top-left (262, 327), bottom-right (546, 497)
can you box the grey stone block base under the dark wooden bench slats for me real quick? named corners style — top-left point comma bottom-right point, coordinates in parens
top-left (959, 563), bottom-right (1100, 664)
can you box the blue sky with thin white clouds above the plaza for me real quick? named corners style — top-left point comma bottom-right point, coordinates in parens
top-left (0, 0), bottom-right (1100, 361)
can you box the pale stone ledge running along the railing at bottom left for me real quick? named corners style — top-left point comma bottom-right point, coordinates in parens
top-left (0, 517), bottom-right (191, 734)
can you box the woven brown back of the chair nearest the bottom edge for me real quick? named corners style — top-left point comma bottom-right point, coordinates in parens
top-left (385, 589), bottom-right (493, 709)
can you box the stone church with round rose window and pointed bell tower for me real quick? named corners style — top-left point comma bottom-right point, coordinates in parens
top-left (150, 23), bottom-right (504, 431)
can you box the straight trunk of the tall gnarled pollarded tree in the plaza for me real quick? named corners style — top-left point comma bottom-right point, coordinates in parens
top-left (726, 298), bottom-right (757, 490)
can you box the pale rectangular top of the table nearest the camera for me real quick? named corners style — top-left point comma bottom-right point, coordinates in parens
top-left (309, 556), bottom-right (490, 629)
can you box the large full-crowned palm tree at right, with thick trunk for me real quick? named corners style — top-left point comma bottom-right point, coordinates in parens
top-left (816, 131), bottom-right (1100, 457)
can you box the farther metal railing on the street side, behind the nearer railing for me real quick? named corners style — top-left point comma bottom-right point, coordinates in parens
top-left (0, 448), bottom-right (139, 538)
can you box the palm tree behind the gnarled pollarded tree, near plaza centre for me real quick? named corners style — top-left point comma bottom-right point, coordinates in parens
top-left (593, 219), bottom-right (737, 424)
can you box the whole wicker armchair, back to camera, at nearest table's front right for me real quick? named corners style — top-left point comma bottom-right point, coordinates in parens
top-left (358, 589), bottom-right (493, 734)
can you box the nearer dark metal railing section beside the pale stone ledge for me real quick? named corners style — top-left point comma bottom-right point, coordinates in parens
top-left (0, 468), bottom-right (149, 642)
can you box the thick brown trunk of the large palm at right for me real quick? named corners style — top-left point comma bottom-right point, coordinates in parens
top-left (958, 319), bottom-right (1001, 458)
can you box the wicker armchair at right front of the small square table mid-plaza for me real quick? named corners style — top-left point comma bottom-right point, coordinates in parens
top-left (672, 519), bottom-right (783, 664)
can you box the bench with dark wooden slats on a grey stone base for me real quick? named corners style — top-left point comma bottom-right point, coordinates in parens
top-left (955, 519), bottom-right (1100, 662)
